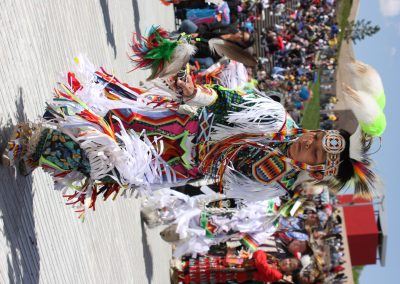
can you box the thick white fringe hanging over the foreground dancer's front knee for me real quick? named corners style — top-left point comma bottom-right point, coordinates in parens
top-left (47, 106), bottom-right (176, 193)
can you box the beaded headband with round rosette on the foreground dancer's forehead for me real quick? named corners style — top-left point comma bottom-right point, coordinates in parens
top-left (322, 130), bottom-right (346, 176)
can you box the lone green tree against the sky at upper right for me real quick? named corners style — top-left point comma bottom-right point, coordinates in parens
top-left (344, 19), bottom-right (381, 44)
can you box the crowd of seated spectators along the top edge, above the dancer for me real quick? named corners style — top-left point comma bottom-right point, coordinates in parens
top-left (162, 0), bottom-right (340, 126)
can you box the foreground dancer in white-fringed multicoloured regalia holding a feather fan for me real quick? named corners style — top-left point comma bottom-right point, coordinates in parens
top-left (3, 27), bottom-right (383, 217)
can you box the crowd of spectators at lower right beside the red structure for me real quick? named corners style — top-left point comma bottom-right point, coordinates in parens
top-left (277, 184), bottom-right (347, 283)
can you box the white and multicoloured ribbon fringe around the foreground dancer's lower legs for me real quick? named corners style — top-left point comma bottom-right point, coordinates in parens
top-left (41, 57), bottom-right (184, 219)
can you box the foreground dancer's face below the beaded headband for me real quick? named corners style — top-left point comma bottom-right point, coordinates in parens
top-left (289, 131), bottom-right (326, 166)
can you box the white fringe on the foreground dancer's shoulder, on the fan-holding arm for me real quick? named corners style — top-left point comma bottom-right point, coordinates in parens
top-left (211, 97), bottom-right (286, 141)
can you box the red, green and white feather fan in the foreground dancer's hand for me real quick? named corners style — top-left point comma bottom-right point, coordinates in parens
top-left (130, 26), bottom-right (196, 80)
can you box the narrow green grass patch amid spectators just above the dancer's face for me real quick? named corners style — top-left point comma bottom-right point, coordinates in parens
top-left (301, 71), bottom-right (321, 129)
